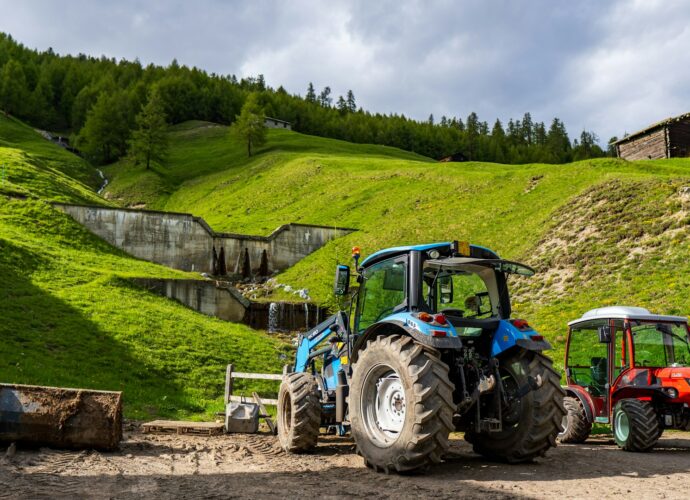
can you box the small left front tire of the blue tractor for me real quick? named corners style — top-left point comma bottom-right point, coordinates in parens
top-left (277, 373), bottom-right (321, 453)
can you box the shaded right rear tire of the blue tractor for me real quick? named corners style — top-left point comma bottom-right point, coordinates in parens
top-left (465, 350), bottom-right (565, 463)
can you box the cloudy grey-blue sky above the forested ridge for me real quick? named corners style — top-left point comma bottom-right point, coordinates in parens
top-left (0, 0), bottom-right (690, 142)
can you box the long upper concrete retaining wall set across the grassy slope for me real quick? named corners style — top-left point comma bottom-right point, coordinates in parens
top-left (54, 203), bottom-right (354, 274)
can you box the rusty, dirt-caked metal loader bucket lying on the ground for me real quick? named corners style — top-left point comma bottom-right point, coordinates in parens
top-left (0, 384), bottom-right (122, 450)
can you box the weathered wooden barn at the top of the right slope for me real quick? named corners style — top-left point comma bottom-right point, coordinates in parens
top-left (613, 113), bottom-right (690, 160)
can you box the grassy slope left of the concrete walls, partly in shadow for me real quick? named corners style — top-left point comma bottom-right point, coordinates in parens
top-left (0, 116), bottom-right (286, 418)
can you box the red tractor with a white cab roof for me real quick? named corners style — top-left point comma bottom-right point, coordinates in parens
top-left (559, 306), bottom-right (690, 451)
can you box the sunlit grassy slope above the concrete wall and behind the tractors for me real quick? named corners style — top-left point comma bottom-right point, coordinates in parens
top-left (106, 124), bottom-right (690, 366)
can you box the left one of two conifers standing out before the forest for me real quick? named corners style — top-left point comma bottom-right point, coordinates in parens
top-left (129, 87), bottom-right (168, 170)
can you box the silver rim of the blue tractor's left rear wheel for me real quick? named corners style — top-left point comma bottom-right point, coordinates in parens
top-left (361, 365), bottom-right (407, 447)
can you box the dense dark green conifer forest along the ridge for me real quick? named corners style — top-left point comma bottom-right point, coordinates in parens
top-left (0, 33), bottom-right (606, 164)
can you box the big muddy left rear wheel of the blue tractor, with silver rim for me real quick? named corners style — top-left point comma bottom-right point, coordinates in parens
top-left (349, 335), bottom-right (455, 473)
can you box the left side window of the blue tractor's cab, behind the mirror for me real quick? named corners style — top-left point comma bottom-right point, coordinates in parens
top-left (356, 259), bottom-right (407, 332)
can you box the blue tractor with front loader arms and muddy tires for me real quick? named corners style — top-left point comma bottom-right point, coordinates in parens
top-left (277, 242), bottom-right (565, 472)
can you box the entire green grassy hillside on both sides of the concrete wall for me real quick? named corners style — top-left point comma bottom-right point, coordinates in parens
top-left (0, 114), bottom-right (690, 410)
